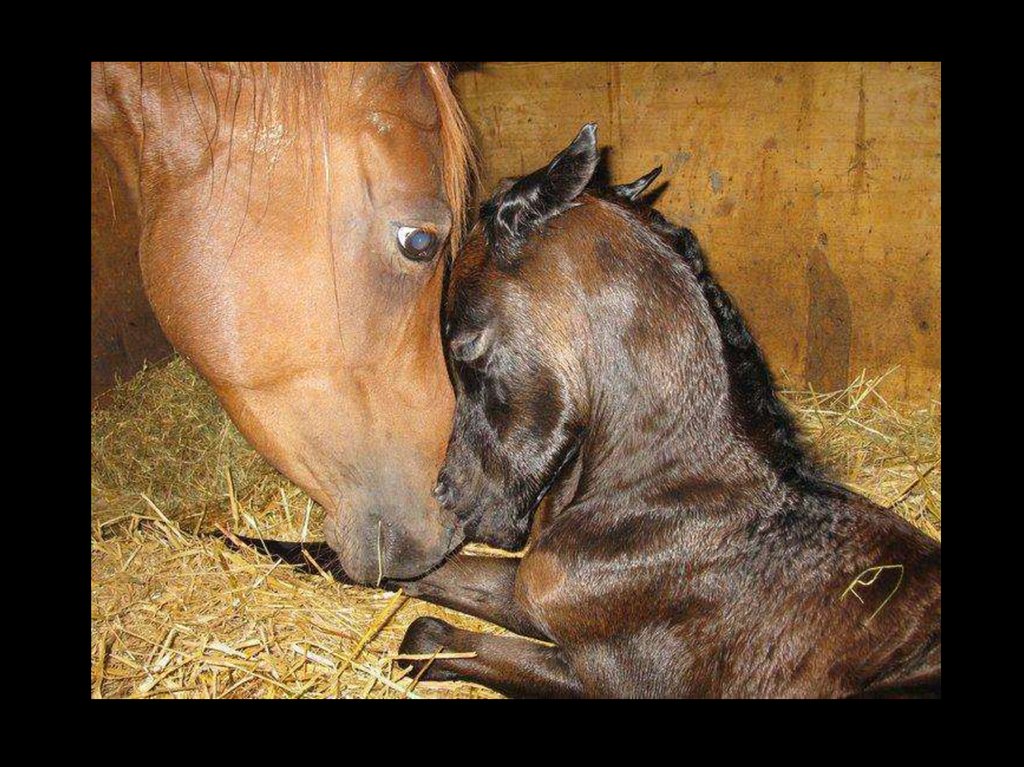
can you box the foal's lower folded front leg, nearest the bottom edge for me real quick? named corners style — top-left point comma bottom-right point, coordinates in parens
top-left (398, 617), bottom-right (583, 697)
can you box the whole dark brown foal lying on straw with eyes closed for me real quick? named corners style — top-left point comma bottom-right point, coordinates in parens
top-left (401, 126), bottom-right (941, 697)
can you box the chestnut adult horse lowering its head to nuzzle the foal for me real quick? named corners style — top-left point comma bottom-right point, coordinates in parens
top-left (92, 62), bottom-right (472, 583)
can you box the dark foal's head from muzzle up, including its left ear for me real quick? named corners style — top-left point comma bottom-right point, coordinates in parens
top-left (435, 126), bottom-right (597, 549)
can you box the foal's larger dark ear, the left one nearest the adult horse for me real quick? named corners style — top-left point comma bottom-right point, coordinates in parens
top-left (484, 123), bottom-right (598, 260)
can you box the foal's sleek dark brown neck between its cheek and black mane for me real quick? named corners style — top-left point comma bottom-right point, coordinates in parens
top-left (580, 222), bottom-right (777, 499)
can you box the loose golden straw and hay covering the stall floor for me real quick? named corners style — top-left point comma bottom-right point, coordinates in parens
top-left (92, 358), bottom-right (941, 697)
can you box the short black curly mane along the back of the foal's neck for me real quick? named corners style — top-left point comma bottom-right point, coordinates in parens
top-left (601, 193), bottom-right (846, 492)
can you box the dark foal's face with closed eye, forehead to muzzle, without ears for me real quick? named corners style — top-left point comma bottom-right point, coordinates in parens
top-left (435, 227), bottom-right (583, 549)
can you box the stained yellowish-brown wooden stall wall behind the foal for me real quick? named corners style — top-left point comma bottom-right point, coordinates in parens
top-left (456, 62), bottom-right (941, 399)
